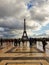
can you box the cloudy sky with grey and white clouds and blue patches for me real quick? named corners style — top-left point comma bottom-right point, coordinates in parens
top-left (0, 0), bottom-right (49, 38)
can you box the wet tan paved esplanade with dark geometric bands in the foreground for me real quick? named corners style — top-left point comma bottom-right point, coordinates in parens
top-left (0, 42), bottom-right (49, 65)
